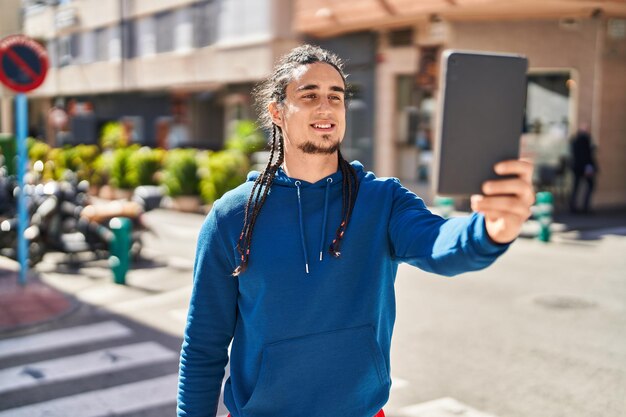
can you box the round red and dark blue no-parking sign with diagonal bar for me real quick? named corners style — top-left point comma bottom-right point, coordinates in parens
top-left (0, 35), bottom-right (48, 93)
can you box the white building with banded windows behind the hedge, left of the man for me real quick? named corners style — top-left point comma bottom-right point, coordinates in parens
top-left (23, 0), bottom-right (296, 149)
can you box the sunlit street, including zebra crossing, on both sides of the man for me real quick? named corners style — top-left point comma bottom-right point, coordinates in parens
top-left (0, 210), bottom-right (626, 417)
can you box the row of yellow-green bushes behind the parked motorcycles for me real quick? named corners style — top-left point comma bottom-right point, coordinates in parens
top-left (18, 121), bottom-right (258, 203)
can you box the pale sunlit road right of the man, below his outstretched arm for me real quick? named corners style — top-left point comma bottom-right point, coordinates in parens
top-left (387, 235), bottom-right (626, 417)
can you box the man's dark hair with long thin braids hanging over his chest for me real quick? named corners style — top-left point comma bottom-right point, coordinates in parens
top-left (233, 45), bottom-right (359, 276)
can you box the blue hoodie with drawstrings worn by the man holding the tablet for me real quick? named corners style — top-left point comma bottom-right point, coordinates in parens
top-left (178, 162), bottom-right (508, 417)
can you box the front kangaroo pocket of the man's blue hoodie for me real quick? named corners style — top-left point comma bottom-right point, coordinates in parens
top-left (242, 326), bottom-right (389, 417)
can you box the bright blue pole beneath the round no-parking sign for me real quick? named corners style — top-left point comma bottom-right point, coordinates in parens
top-left (15, 93), bottom-right (28, 285)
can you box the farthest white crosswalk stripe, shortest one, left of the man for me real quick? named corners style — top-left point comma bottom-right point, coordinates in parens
top-left (0, 321), bottom-right (133, 359)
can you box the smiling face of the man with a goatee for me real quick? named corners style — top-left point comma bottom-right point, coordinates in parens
top-left (270, 63), bottom-right (346, 154)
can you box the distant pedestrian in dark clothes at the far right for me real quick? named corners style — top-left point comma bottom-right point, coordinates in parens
top-left (569, 123), bottom-right (598, 213)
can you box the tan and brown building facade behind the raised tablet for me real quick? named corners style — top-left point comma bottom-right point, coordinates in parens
top-left (294, 0), bottom-right (626, 207)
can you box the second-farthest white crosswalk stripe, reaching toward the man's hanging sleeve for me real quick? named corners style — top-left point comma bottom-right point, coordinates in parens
top-left (0, 342), bottom-right (177, 394)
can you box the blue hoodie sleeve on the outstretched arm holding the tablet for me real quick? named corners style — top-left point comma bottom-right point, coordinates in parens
top-left (389, 180), bottom-right (509, 276)
